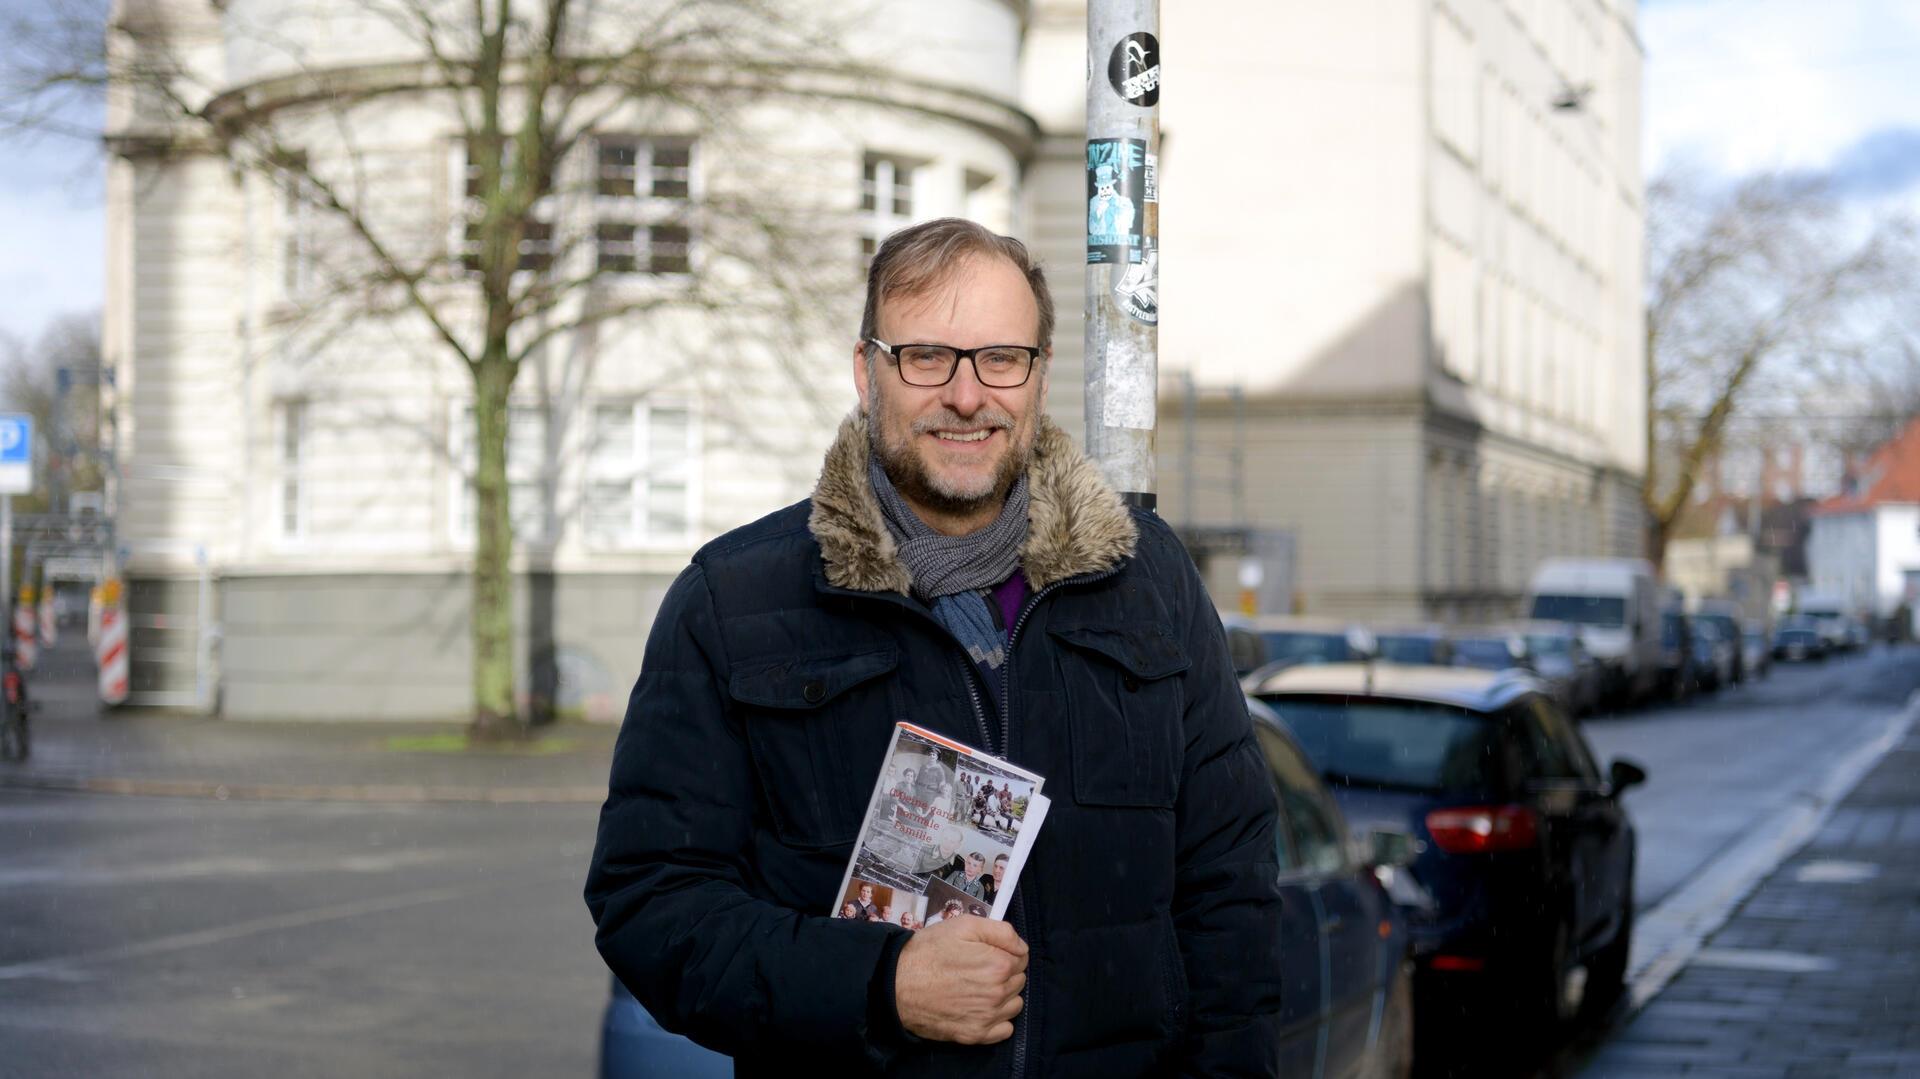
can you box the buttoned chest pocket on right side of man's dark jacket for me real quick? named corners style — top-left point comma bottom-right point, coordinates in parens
top-left (1046, 624), bottom-right (1192, 808)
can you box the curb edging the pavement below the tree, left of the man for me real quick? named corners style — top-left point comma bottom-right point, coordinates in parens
top-left (0, 776), bottom-right (607, 806)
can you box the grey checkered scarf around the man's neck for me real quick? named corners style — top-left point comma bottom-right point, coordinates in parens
top-left (866, 459), bottom-right (1027, 668)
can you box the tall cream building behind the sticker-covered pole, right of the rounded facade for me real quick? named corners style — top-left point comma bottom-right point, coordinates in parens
top-left (1025, 0), bottom-right (1645, 618)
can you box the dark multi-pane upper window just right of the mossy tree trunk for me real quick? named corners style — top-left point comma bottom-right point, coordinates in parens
top-left (593, 134), bottom-right (693, 275)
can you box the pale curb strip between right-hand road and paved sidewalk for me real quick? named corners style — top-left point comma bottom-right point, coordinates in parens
top-left (1620, 691), bottom-right (1920, 1021)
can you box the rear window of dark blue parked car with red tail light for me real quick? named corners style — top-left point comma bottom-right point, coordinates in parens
top-left (1261, 695), bottom-right (1494, 791)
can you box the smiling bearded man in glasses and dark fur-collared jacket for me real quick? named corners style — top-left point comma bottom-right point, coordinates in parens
top-left (588, 219), bottom-right (1279, 1077)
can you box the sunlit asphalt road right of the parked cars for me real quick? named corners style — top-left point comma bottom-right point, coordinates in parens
top-left (1582, 645), bottom-right (1920, 908)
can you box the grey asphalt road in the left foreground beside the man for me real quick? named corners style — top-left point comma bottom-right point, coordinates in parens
top-left (0, 791), bottom-right (607, 1079)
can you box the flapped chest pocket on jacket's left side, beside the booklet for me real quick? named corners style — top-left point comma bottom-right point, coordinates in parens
top-left (728, 649), bottom-right (899, 849)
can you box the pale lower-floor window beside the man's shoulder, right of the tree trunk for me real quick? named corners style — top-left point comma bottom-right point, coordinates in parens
top-left (582, 403), bottom-right (695, 547)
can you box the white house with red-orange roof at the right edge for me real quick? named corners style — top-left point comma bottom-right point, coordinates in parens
top-left (1807, 419), bottom-right (1920, 628)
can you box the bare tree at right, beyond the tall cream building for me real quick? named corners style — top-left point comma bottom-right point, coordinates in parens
top-left (1644, 169), bottom-right (1916, 563)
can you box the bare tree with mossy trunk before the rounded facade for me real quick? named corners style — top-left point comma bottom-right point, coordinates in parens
top-left (0, 0), bottom-right (860, 739)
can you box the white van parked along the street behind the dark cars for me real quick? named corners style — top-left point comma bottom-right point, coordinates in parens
top-left (1526, 559), bottom-right (1661, 705)
